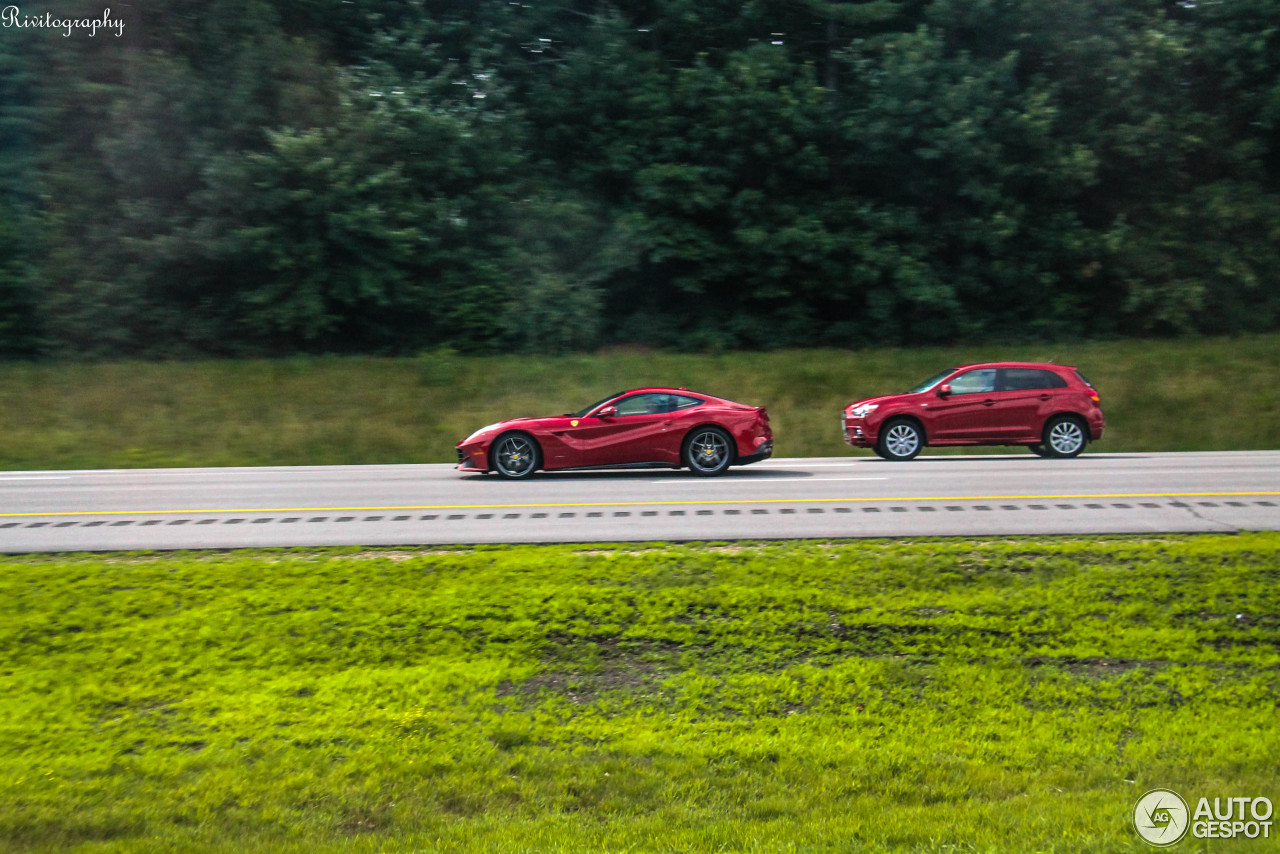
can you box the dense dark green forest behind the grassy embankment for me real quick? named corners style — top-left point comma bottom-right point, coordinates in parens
top-left (0, 0), bottom-right (1280, 359)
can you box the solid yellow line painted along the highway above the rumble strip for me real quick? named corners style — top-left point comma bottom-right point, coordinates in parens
top-left (0, 492), bottom-right (1280, 519)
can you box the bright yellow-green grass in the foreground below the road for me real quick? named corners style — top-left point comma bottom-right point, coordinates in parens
top-left (0, 534), bottom-right (1280, 854)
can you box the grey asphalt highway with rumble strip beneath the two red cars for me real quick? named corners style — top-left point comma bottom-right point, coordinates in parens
top-left (0, 451), bottom-right (1280, 553)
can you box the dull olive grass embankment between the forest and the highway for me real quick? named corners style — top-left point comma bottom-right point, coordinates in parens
top-left (0, 335), bottom-right (1280, 470)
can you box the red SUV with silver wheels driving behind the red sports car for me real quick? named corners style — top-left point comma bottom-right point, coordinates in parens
top-left (844, 362), bottom-right (1106, 460)
